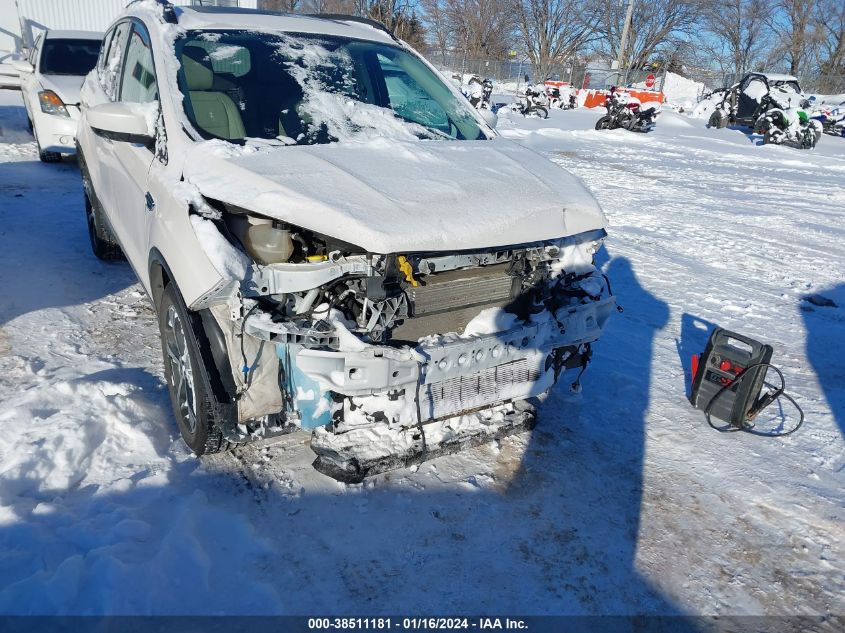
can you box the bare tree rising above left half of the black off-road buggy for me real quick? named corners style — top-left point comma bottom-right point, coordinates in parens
top-left (702, 0), bottom-right (771, 77)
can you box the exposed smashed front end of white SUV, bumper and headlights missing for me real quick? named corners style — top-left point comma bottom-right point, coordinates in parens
top-left (194, 201), bottom-right (615, 482)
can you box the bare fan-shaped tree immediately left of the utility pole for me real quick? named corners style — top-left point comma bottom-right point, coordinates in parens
top-left (516, 0), bottom-right (601, 79)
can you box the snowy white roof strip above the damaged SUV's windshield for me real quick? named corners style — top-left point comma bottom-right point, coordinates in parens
top-left (154, 7), bottom-right (394, 43)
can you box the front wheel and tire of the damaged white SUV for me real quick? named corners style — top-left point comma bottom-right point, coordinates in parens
top-left (158, 282), bottom-right (234, 456)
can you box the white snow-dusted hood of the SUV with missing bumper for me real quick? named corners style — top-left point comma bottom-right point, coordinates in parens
top-left (184, 138), bottom-right (606, 253)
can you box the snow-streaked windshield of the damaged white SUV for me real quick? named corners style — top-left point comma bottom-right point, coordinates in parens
top-left (176, 31), bottom-right (487, 145)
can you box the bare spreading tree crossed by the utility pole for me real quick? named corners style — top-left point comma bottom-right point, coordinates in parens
top-left (599, 0), bottom-right (700, 68)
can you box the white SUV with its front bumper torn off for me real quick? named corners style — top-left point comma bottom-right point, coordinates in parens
top-left (78, 0), bottom-right (614, 481)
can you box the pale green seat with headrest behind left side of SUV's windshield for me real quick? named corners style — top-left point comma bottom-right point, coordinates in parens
top-left (182, 55), bottom-right (246, 140)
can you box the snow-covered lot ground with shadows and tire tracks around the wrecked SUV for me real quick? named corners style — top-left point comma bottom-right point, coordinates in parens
top-left (0, 91), bottom-right (845, 614)
